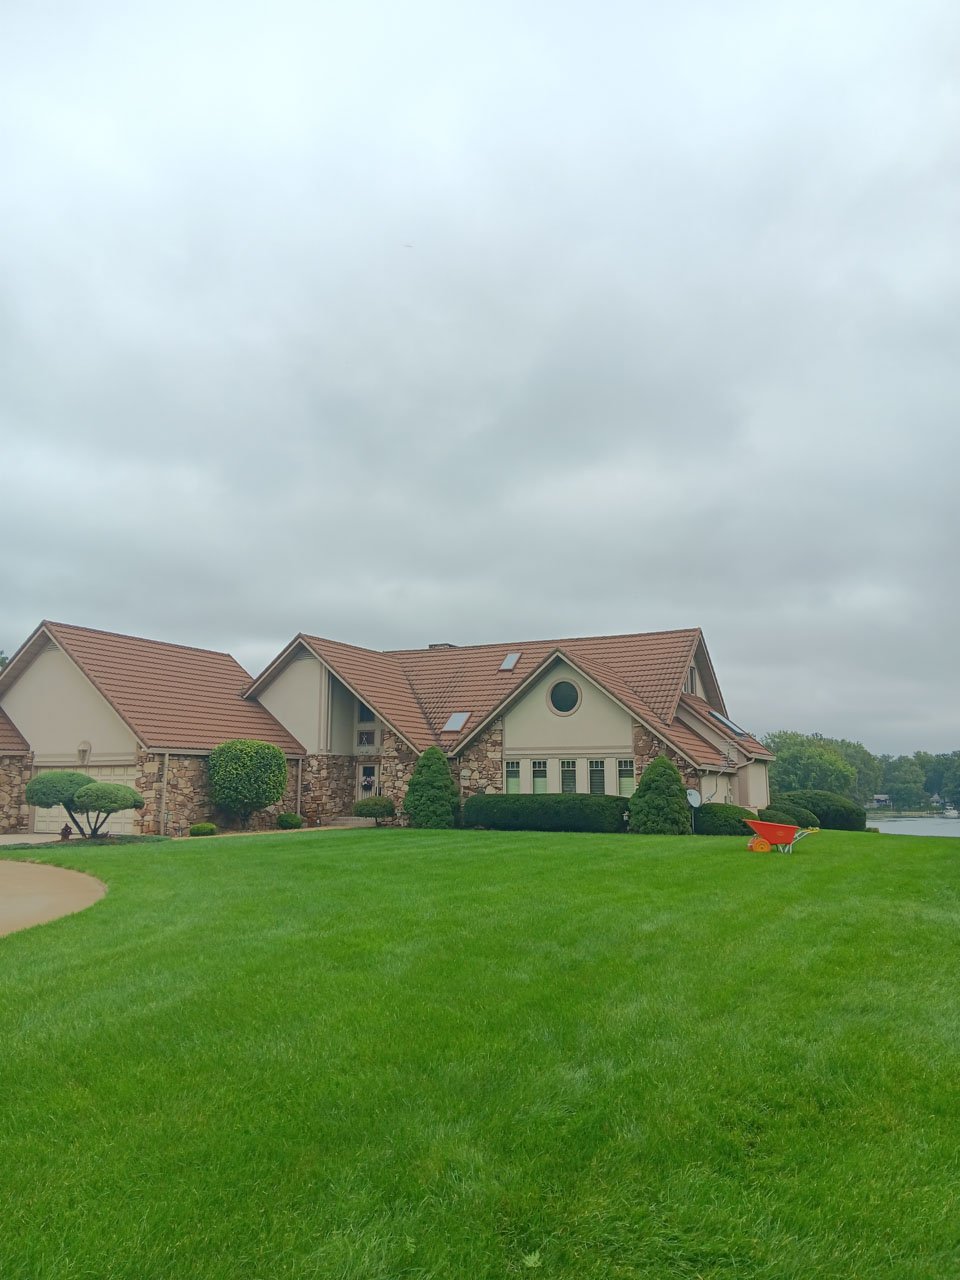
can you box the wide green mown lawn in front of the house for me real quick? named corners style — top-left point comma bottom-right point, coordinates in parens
top-left (0, 829), bottom-right (960, 1280)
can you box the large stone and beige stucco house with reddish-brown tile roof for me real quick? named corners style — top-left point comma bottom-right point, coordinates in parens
top-left (0, 622), bottom-right (772, 832)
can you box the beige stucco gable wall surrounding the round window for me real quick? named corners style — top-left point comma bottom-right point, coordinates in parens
top-left (503, 662), bottom-right (634, 759)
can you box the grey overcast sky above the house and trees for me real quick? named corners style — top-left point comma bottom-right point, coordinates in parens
top-left (0, 0), bottom-right (960, 751)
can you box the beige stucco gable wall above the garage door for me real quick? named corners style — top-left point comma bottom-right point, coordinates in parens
top-left (0, 645), bottom-right (137, 767)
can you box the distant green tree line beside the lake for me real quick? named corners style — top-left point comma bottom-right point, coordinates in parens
top-left (763, 730), bottom-right (960, 809)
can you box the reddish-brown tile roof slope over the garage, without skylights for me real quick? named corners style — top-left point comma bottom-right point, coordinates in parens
top-left (42, 622), bottom-right (306, 755)
